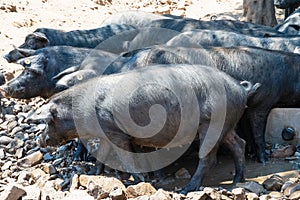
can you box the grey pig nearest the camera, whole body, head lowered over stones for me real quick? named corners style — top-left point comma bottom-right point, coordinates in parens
top-left (36, 65), bottom-right (259, 193)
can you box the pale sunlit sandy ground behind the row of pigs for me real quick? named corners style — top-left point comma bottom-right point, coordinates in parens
top-left (0, 0), bottom-right (283, 77)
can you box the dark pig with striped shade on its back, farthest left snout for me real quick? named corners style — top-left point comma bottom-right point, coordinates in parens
top-left (3, 24), bottom-right (137, 62)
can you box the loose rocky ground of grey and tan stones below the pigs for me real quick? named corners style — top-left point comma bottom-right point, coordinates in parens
top-left (0, 94), bottom-right (300, 200)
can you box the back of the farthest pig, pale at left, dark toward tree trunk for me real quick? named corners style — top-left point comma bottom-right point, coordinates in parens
top-left (102, 11), bottom-right (281, 37)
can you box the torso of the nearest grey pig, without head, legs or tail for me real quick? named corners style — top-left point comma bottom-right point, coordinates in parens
top-left (73, 65), bottom-right (247, 147)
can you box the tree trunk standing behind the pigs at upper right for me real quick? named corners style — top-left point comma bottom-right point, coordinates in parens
top-left (243, 0), bottom-right (277, 26)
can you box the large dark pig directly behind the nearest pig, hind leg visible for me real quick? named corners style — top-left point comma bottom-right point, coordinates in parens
top-left (108, 46), bottom-right (300, 162)
